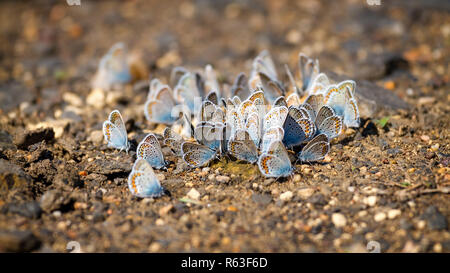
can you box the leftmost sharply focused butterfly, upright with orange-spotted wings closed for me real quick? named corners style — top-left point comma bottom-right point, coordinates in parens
top-left (103, 110), bottom-right (130, 153)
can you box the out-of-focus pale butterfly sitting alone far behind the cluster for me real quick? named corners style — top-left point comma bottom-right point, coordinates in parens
top-left (92, 43), bottom-right (131, 90)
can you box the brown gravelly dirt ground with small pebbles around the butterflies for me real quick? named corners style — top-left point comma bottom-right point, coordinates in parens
top-left (0, 0), bottom-right (450, 252)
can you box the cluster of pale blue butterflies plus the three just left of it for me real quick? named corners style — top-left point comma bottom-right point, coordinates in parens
top-left (103, 45), bottom-right (359, 197)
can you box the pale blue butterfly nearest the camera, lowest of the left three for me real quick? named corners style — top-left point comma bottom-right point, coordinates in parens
top-left (128, 158), bottom-right (164, 198)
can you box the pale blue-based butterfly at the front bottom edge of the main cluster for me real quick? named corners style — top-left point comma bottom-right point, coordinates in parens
top-left (258, 140), bottom-right (294, 178)
